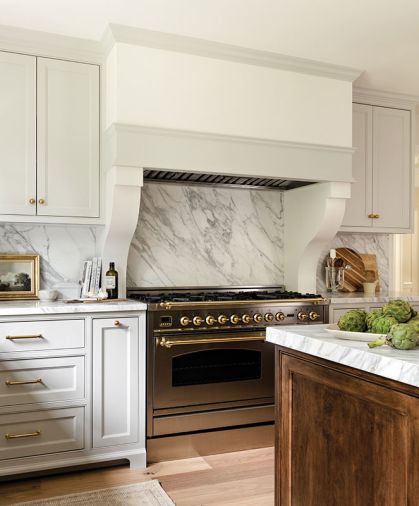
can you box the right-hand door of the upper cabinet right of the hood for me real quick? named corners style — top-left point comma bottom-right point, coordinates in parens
top-left (373, 107), bottom-right (412, 229)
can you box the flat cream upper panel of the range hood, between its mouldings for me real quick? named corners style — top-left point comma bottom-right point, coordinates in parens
top-left (106, 43), bottom-right (352, 147)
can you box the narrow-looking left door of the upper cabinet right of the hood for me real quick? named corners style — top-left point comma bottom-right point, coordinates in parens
top-left (342, 104), bottom-right (373, 228)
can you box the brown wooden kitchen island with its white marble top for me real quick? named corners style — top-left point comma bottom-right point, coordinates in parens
top-left (267, 325), bottom-right (419, 506)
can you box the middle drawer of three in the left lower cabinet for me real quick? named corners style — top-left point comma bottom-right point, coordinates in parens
top-left (0, 357), bottom-right (85, 406)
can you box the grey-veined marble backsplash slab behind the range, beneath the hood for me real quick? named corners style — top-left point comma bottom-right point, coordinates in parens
top-left (127, 184), bottom-right (284, 287)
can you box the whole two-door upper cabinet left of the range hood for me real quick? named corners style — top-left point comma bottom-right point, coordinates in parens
top-left (0, 52), bottom-right (100, 222)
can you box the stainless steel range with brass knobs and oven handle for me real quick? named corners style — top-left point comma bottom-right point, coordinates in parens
top-left (128, 286), bottom-right (328, 461)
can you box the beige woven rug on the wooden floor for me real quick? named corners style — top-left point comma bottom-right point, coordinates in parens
top-left (14, 480), bottom-right (175, 506)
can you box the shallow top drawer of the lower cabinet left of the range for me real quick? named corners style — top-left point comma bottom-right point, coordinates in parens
top-left (0, 320), bottom-right (84, 353)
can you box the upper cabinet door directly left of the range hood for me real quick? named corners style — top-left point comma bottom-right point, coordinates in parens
top-left (37, 58), bottom-right (99, 217)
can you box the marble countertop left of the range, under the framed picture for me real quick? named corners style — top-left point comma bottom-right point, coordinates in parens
top-left (0, 300), bottom-right (147, 318)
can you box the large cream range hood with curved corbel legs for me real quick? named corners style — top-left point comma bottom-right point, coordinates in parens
top-left (103, 27), bottom-right (359, 295)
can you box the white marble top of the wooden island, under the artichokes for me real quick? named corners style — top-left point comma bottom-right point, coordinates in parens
top-left (266, 325), bottom-right (419, 388)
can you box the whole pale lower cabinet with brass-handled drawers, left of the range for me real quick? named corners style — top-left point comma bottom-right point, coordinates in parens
top-left (0, 311), bottom-right (146, 478)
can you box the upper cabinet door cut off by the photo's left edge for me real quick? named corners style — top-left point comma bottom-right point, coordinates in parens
top-left (0, 51), bottom-right (36, 215)
